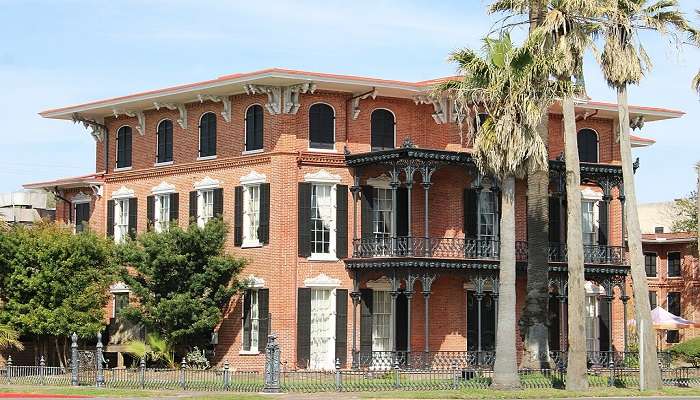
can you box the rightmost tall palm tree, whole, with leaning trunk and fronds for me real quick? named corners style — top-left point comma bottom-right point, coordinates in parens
top-left (600, 0), bottom-right (697, 390)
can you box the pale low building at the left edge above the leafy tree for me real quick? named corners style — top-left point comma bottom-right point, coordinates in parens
top-left (0, 190), bottom-right (56, 225)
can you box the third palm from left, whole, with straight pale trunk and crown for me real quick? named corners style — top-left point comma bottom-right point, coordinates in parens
top-left (529, 0), bottom-right (602, 390)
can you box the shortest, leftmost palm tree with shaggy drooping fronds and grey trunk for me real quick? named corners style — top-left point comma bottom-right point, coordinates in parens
top-left (438, 34), bottom-right (560, 388)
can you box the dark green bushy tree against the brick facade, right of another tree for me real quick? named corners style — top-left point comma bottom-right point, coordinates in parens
top-left (120, 219), bottom-right (245, 346)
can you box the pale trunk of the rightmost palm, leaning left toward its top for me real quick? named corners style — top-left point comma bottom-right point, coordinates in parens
top-left (617, 87), bottom-right (662, 390)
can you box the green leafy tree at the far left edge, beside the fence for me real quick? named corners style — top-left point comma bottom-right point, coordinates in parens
top-left (0, 223), bottom-right (117, 365)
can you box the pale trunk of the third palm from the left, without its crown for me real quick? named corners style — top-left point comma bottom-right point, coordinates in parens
top-left (562, 97), bottom-right (588, 390)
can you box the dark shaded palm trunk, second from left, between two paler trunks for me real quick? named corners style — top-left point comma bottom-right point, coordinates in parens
top-left (520, 113), bottom-right (550, 369)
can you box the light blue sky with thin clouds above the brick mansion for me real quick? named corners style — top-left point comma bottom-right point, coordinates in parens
top-left (0, 0), bottom-right (700, 202)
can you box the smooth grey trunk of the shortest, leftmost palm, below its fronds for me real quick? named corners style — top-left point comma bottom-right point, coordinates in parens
top-left (493, 176), bottom-right (520, 389)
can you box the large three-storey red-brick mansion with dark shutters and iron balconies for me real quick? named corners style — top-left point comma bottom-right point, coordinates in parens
top-left (26, 69), bottom-right (683, 369)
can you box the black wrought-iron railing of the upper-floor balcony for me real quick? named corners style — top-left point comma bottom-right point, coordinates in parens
top-left (353, 236), bottom-right (626, 266)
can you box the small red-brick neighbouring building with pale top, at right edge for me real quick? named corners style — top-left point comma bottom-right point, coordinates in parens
top-left (639, 202), bottom-right (700, 348)
